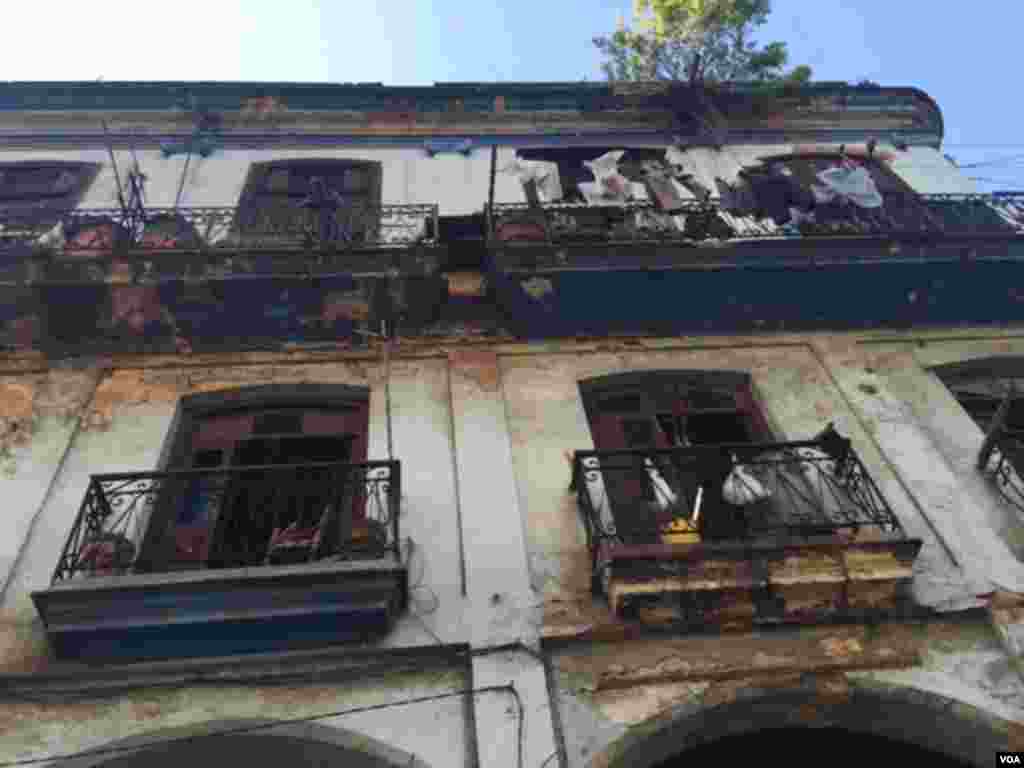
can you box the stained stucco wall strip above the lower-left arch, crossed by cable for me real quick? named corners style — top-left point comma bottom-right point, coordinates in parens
top-left (0, 672), bottom-right (471, 768)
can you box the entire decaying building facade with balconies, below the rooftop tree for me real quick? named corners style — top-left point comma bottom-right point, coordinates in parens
top-left (0, 83), bottom-right (1024, 768)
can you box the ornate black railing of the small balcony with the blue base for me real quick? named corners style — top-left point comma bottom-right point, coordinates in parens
top-left (53, 461), bottom-right (401, 583)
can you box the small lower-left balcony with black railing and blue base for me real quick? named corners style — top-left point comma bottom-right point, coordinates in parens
top-left (33, 461), bottom-right (406, 660)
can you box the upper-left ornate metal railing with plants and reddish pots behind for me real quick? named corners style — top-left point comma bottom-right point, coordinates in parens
top-left (0, 205), bottom-right (438, 257)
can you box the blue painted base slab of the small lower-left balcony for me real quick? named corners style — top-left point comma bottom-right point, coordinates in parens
top-left (33, 557), bottom-right (406, 663)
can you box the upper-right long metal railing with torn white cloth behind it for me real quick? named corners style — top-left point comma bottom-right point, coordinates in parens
top-left (488, 194), bottom-right (1024, 244)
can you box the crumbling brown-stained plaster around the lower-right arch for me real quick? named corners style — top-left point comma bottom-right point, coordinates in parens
top-left (554, 618), bottom-right (1024, 768)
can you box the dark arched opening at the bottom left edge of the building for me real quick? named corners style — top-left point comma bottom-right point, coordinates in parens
top-left (53, 720), bottom-right (428, 768)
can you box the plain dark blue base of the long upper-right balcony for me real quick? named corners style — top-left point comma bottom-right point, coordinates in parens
top-left (488, 243), bottom-right (1024, 338)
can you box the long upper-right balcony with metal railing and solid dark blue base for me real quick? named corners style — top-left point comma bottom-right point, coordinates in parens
top-left (485, 193), bottom-right (1024, 339)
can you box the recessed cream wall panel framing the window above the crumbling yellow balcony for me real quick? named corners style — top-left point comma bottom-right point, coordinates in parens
top-left (502, 340), bottom-right (985, 618)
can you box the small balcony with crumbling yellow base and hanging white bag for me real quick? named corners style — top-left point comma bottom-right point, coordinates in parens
top-left (571, 428), bottom-right (921, 625)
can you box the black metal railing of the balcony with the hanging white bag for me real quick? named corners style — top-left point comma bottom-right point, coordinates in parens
top-left (571, 429), bottom-right (902, 564)
